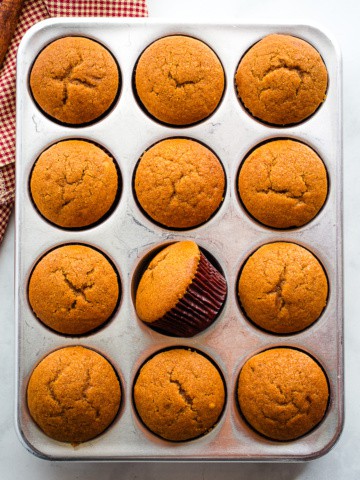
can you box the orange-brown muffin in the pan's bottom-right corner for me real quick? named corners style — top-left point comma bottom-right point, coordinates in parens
top-left (237, 348), bottom-right (329, 440)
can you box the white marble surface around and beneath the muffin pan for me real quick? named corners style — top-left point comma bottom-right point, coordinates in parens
top-left (0, 0), bottom-right (360, 480)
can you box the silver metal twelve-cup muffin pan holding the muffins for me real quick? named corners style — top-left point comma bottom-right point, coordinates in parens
top-left (15, 18), bottom-right (344, 462)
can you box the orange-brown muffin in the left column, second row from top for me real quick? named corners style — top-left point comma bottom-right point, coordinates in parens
top-left (30, 140), bottom-right (118, 228)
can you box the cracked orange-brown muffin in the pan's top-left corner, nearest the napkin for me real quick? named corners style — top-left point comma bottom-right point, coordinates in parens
top-left (30, 37), bottom-right (120, 125)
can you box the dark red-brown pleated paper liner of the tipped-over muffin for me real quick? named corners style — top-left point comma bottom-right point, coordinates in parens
top-left (150, 253), bottom-right (227, 337)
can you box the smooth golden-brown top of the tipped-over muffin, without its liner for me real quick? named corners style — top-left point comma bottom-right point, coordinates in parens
top-left (135, 240), bottom-right (200, 323)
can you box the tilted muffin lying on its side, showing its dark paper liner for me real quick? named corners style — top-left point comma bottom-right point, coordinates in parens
top-left (135, 241), bottom-right (227, 337)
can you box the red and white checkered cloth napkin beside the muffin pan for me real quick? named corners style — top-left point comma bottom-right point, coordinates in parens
top-left (0, 0), bottom-right (147, 244)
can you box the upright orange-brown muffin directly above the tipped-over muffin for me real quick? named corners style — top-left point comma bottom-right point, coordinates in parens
top-left (135, 138), bottom-right (225, 228)
